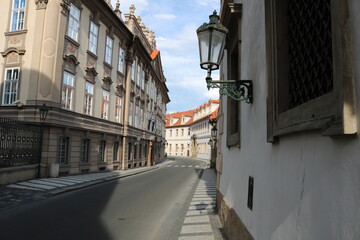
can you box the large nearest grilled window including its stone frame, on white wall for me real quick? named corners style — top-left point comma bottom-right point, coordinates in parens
top-left (265, 0), bottom-right (357, 138)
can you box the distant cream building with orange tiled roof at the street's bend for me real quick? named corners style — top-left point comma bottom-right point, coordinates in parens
top-left (166, 100), bottom-right (219, 160)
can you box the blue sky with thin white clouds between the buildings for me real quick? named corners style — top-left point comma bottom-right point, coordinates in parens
top-left (112, 0), bottom-right (220, 112)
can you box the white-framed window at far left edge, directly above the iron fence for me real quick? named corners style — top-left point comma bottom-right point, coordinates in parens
top-left (2, 68), bottom-right (20, 105)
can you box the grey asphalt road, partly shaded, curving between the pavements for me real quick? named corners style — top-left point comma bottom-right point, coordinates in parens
top-left (0, 158), bottom-right (204, 240)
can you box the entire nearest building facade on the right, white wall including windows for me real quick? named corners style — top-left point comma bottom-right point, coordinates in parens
top-left (217, 0), bottom-right (360, 240)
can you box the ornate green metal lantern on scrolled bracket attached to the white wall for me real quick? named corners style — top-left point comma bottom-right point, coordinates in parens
top-left (196, 11), bottom-right (253, 103)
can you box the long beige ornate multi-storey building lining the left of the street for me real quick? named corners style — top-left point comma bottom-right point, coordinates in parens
top-left (0, 0), bottom-right (170, 186)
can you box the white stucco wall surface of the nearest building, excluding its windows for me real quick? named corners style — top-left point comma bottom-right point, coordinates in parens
top-left (219, 0), bottom-right (360, 240)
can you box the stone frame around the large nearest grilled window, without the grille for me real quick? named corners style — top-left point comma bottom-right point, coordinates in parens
top-left (265, 0), bottom-right (357, 142)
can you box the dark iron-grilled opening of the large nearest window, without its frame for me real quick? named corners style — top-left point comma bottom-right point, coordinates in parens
top-left (288, 0), bottom-right (333, 108)
